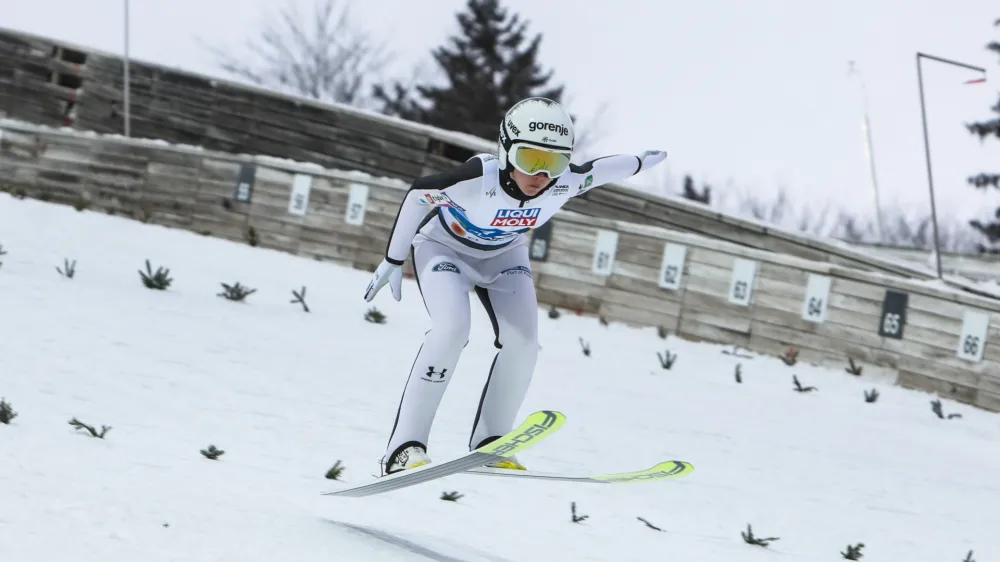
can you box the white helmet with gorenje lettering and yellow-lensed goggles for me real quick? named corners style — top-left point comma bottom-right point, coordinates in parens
top-left (497, 98), bottom-right (576, 178)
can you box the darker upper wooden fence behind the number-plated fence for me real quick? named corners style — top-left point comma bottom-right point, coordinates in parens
top-left (0, 23), bottom-right (984, 279)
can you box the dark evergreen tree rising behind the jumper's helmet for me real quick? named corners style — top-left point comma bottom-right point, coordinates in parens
top-left (373, 0), bottom-right (563, 139)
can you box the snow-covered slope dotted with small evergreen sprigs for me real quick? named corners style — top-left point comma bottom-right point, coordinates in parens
top-left (0, 190), bottom-right (1000, 562)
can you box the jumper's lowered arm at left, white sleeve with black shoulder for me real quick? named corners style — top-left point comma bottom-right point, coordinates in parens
top-left (385, 157), bottom-right (483, 265)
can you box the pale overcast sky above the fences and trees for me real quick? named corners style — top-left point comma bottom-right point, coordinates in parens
top-left (0, 0), bottom-right (1000, 228)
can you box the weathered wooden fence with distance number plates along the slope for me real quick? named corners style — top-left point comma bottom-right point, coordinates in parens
top-left (0, 120), bottom-right (1000, 411)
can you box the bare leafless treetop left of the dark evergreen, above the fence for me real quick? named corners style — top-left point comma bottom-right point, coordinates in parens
top-left (202, 0), bottom-right (391, 105)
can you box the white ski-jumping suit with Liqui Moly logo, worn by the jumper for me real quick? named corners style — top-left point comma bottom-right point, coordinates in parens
top-left (378, 151), bottom-right (666, 464)
